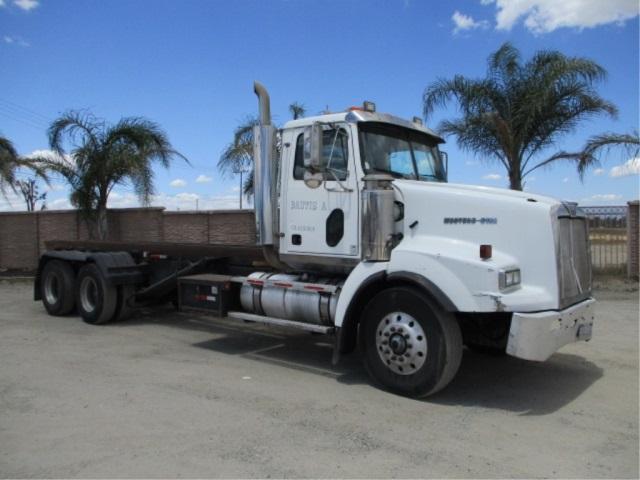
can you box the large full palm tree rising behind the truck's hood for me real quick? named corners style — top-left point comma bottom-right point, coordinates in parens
top-left (423, 43), bottom-right (617, 190)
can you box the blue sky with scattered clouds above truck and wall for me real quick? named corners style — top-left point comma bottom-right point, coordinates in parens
top-left (0, 0), bottom-right (640, 209)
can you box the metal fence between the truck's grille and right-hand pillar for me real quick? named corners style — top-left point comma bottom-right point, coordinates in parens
top-left (581, 205), bottom-right (629, 274)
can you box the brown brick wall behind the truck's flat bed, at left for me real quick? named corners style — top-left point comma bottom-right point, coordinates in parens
top-left (0, 208), bottom-right (255, 270)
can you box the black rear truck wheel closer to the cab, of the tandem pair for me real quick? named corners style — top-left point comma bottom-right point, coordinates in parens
top-left (76, 263), bottom-right (118, 325)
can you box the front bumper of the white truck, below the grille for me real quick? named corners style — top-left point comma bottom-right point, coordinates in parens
top-left (507, 298), bottom-right (596, 362)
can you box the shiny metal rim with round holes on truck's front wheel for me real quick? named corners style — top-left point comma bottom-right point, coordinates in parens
top-left (376, 312), bottom-right (427, 375)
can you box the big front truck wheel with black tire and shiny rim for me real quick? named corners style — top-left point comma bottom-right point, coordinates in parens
top-left (360, 287), bottom-right (462, 397)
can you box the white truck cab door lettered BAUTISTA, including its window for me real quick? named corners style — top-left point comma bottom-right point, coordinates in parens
top-left (280, 124), bottom-right (360, 258)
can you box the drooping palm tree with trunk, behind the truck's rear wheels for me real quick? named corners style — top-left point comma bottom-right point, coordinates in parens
top-left (39, 111), bottom-right (188, 240)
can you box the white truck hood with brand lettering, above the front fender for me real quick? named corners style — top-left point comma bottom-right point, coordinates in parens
top-left (392, 180), bottom-right (561, 308)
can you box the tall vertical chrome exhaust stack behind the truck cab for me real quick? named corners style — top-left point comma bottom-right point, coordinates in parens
top-left (253, 82), bottom-right (287, 270)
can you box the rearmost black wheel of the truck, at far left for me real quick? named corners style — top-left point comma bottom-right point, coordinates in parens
top-left (40, 260), bottom-right (76, 316)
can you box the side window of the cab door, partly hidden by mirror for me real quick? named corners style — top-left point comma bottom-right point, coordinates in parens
top-left (293, 128), bottom-right (349, 180)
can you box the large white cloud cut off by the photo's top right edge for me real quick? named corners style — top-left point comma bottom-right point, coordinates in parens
top-left (488, 0), bottom-right (638, 34)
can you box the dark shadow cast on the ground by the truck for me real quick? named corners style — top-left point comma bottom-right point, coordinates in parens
top-left (117, 309), bottom-right (602, 415)
